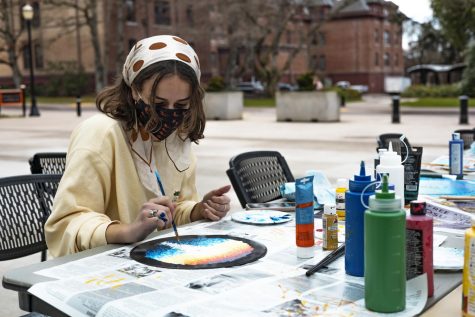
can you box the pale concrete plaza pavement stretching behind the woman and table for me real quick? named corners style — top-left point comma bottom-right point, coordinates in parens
top-left (0, 95), bottom-right (475, 316)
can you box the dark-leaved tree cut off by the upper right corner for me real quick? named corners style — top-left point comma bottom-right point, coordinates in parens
top-left (431, 0), bottom-right (475, 97)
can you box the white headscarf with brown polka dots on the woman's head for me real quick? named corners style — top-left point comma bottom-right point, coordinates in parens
top-left (122, 35), bottom-right (201, 87)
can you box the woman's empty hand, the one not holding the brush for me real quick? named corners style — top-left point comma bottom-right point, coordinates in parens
top-left (192, 185), bottom-right (231, 221)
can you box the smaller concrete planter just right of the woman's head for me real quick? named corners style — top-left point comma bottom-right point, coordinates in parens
top-left (204, 91), bottom-right (244, 120)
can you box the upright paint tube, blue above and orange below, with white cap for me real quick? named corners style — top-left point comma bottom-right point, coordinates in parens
top-left (295, 176), bottom-right (315, 259)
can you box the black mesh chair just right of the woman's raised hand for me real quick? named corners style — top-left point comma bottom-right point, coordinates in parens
top-left (226, 151), bottom-right (295, 208)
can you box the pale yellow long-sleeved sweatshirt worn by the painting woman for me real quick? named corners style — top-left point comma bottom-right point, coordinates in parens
top-left (45, 114), bottom-right (199, 256)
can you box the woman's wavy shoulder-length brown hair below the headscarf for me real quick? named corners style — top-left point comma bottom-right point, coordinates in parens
top-left (96, 60), bottom-right (206, 143)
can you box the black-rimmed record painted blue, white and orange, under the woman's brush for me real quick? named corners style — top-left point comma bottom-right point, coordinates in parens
top-left (130, 235), bottom-right (267, 270)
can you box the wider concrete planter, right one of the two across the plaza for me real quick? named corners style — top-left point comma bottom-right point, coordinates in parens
top-left (276, 91), bottom-right (340, 122)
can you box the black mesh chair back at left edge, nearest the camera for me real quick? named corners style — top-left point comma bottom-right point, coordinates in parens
top-left (0, 174), bottom-right (62, 261)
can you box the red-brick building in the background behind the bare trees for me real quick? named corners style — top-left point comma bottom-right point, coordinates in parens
top-left (0, 0), bottom-right (403, 92)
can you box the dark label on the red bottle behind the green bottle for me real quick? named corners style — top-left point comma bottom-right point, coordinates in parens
top-left (406, 229), bottom-right (424, 279)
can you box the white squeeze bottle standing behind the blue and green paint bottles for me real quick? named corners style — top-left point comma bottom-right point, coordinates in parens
top-left (376, 142), bottom-right (404, 208)
